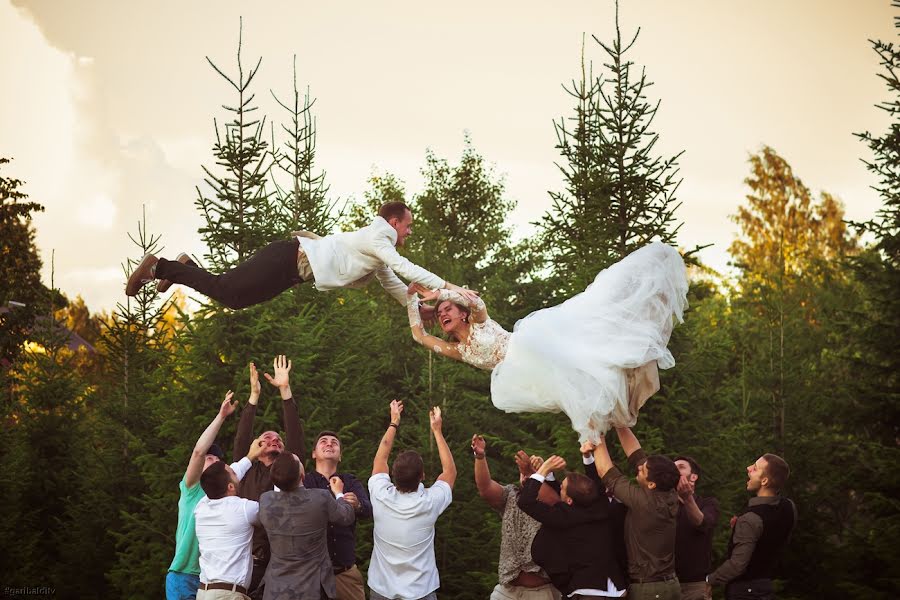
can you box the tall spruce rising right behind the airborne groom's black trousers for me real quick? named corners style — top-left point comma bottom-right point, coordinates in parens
top-left (195, 18), bottom-right (281, 269)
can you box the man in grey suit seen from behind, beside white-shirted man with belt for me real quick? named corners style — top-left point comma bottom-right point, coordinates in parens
top-left (259, 452), bottom-right (354, 600)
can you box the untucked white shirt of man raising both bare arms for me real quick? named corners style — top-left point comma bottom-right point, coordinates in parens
top-left (368, 473), bottom-right (453, 599)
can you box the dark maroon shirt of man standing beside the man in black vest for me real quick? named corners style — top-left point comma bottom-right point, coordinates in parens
top-left (675, 495), bottom-right (719, 583)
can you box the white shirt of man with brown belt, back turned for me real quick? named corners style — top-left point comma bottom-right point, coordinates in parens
top-left (194, 496), bottom-right (259, 588)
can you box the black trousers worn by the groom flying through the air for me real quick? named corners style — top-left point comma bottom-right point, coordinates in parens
top-left (156, 238), bottom-right (303, 308)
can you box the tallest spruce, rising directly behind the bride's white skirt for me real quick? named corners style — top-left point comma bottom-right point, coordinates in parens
top-left (539, 2), bottom-right (696, 296)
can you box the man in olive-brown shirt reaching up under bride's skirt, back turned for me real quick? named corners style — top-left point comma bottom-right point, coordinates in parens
top-left (582, 428), bottom-right (681, 600)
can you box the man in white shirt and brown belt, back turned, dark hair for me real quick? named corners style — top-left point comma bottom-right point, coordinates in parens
top-left (194, 462), bottom-right (259, 600)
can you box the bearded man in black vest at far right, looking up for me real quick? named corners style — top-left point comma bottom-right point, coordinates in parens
top-left (707, 454), bottom-right (797, 600)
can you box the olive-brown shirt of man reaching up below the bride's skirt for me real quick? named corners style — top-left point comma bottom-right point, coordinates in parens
top-left (603, 449), bottom-right (679, 581)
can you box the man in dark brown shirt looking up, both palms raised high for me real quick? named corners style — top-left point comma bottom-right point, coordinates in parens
top-left (234, 355), bottom-right (304, 599)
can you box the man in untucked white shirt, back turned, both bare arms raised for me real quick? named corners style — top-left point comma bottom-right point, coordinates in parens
top-left (368, 400), bottom-right (456, 600)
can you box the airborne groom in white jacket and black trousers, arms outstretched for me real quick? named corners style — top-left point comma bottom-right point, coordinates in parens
top-left (125, 202), bottom-right (475, 317)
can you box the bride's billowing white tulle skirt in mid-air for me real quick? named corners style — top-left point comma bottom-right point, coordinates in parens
top-left (491, 242), bottom-right (688, 442)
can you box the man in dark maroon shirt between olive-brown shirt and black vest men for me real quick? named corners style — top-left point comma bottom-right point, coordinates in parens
top-left (675, 456), bottom-right (719, 600)
